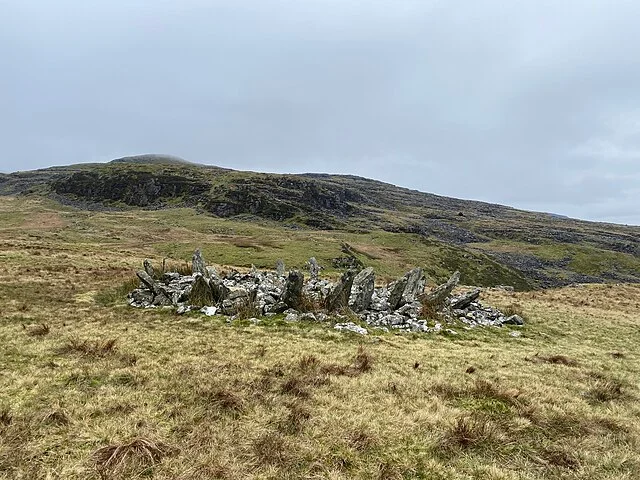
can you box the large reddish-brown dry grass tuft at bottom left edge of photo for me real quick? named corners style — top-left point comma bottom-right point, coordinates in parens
top-left (93, 438), bottom-right (176, 478)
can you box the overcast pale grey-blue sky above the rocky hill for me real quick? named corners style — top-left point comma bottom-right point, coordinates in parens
top-left (0, 0), bottom-right (640, 225)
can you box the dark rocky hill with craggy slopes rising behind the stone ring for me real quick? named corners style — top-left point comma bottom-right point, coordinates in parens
top-left (0, 155), bottom-right (640, 289)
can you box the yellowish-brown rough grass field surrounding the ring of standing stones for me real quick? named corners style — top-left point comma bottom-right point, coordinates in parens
top-left (0, 197), bottom-right (640, 479)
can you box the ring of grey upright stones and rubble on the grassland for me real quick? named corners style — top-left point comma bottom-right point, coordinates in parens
top-left (129, 250), bottom-right (523, 332)
